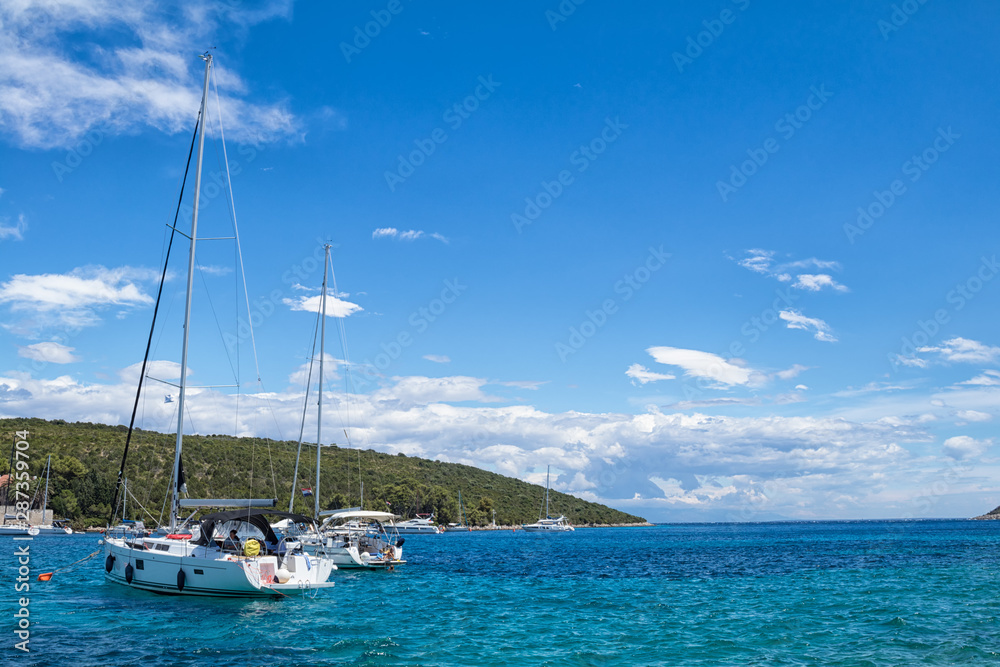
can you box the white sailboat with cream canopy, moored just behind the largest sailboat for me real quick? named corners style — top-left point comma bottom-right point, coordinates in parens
top-left (275, 244), bottom-right (406, 570)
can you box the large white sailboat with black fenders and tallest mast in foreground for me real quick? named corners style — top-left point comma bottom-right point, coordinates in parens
top-left (103, 53), bottom-right (336, 597)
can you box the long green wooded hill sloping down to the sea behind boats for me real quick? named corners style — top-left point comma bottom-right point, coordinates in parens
top-left (0, 419), bottom-right (644, 527)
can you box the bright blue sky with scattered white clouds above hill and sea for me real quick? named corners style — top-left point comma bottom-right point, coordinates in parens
top-left (0, 0), bottom-right (1000, 521)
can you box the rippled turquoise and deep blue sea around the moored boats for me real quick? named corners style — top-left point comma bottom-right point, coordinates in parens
top-left (0, 520), bottom-right (1000, 667)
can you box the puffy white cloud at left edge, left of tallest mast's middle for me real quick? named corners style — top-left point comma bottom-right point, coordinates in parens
top-left (0, 266), bottom-right (158, 328)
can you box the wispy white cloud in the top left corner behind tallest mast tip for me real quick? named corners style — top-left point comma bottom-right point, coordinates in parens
top-left (0, 0), bottom-right (302, 148)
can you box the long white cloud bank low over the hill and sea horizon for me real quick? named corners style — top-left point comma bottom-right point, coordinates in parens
top-left (0, 362), bottom-right (968, 520)
